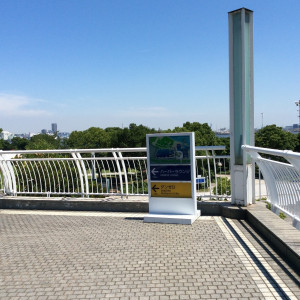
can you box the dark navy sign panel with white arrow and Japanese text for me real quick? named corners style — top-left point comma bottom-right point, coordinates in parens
top-left (150, 165), bottom-right (191, 181)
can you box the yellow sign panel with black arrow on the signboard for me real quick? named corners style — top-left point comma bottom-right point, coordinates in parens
top-left (151, 182), bottom-right (192, 198)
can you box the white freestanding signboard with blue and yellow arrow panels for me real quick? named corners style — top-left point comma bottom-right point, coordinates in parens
top-left (144, 132), bottom-right (199, 224)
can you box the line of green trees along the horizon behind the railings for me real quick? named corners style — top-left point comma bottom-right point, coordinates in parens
top-left (0, 122), bottom-right (300, 154)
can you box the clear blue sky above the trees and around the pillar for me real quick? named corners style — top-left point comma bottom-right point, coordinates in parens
top-left (0, 0), bottom-right (300, 133)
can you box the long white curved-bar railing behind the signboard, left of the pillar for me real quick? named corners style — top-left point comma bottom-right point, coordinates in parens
top-left (0, 146), bottom-right (230, 199)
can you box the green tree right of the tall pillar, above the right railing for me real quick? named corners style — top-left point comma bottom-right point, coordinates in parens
top-left (255, 125), bottom-right (299, 151)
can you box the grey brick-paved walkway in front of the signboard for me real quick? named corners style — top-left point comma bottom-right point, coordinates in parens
top-left (0, 210), bottom-right (300, 300)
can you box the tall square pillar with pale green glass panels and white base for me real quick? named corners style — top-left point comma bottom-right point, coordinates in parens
top-left (228, 8), bottom-right (254, 206)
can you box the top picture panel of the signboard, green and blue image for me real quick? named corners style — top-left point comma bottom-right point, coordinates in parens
top-left (148, 135), bottom-right (191, 165)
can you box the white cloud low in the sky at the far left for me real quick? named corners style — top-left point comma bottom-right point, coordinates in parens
top-left (0, 93), bottom-right (50, 117)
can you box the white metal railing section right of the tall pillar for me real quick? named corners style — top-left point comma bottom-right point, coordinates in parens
top-left (242, 145), bottom-right (300, 229)
